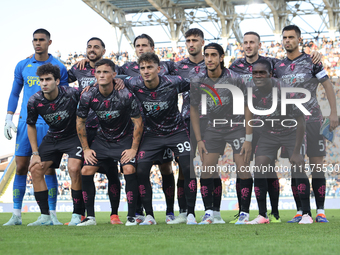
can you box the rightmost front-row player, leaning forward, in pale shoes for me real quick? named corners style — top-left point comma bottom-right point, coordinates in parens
top-left (247, 59), bottom-right (313, 224)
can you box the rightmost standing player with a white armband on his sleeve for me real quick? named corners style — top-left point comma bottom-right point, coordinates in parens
top-left (274, 25), bottom-right (339, 223)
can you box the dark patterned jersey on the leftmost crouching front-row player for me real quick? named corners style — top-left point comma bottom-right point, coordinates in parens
top-left (26, 86), bottom-right (80, 139)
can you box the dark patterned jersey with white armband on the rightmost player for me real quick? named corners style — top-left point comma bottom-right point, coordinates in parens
top-left (274, 53), bottom-right (329, 122)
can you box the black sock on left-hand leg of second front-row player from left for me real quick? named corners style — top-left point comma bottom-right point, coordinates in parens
top-left (81, 175), bottom-right (96, 217)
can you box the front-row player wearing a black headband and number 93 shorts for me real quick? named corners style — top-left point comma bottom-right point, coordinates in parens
top-left (190, 43), bottom-right (252, 224)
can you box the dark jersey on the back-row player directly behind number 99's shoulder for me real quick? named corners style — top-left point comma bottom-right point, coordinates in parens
top-left (175, 58), bottom-right (205, 120)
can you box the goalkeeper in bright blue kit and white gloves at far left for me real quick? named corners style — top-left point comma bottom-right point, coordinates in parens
top-left (4, 29), bottom-right (68, 226)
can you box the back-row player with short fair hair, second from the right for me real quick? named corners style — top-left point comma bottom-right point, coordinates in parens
top-left (229, 32), bottom-right (321, 223)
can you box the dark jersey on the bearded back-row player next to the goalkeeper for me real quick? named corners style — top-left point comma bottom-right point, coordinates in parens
top-left (67, 62), bottom-right (99, 129)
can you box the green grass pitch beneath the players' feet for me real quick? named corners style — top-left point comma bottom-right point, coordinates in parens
top-left (0, 210), bottom-right (340, 255)
